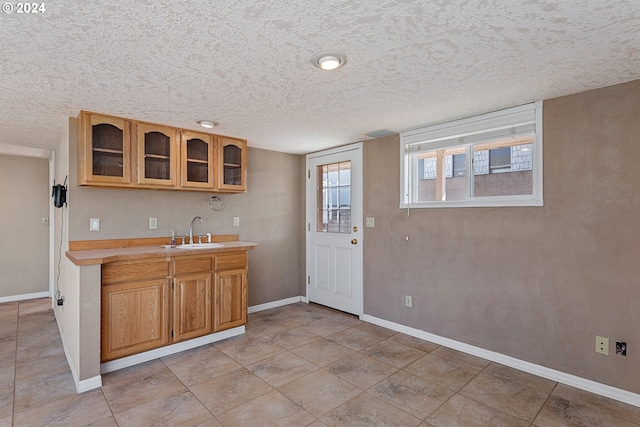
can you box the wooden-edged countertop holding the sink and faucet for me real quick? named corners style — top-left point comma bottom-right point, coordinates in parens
top-left (66, 241), bottom-right (258, 266)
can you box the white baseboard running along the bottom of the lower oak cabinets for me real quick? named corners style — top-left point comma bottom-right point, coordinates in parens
top-left (100, 326), bottom-right (245, 374)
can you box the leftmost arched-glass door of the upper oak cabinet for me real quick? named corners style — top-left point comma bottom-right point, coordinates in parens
top-left (78, 111), bottom-right (131, 185)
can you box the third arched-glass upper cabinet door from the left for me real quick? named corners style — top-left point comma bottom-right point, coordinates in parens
top-left (180, 131), bottom-right (214, 190)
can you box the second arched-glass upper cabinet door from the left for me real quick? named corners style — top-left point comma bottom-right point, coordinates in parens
top-left (132, 123), bottom-right (179, 187)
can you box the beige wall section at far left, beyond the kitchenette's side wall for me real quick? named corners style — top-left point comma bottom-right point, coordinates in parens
top-left (0, 155), bottom-right (50, 298)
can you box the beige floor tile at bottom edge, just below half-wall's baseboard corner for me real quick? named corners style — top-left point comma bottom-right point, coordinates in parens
top-left (13, 390), bottom-right (111, 427)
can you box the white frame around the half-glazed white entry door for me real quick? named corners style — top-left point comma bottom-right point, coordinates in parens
top-left (305, 142), bottom-right (364, 316)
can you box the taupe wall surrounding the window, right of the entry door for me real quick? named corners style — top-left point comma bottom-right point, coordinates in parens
top-left (364, 81), bottom-right (640, 393)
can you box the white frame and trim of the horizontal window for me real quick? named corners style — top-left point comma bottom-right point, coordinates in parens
top-left (400, 101), bottom-right (544, 209)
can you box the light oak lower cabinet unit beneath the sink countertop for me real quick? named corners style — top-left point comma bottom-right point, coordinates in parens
top-left (100, 252), bottom-right (247, 362)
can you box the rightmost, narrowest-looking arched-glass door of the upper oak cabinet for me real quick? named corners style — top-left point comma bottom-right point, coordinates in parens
top-left (216, 136), bottom-right (247, 192)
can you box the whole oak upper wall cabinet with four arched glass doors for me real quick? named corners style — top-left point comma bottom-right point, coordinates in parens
top-left (77, 111), bottom-right (247, 193)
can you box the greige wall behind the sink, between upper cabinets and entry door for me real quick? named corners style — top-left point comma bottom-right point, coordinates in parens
top-left (69, 120), bottom-right (304, 306)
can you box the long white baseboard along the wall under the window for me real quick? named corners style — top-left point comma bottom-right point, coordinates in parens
top-left (360, 314), bottom-right (640, 407)
